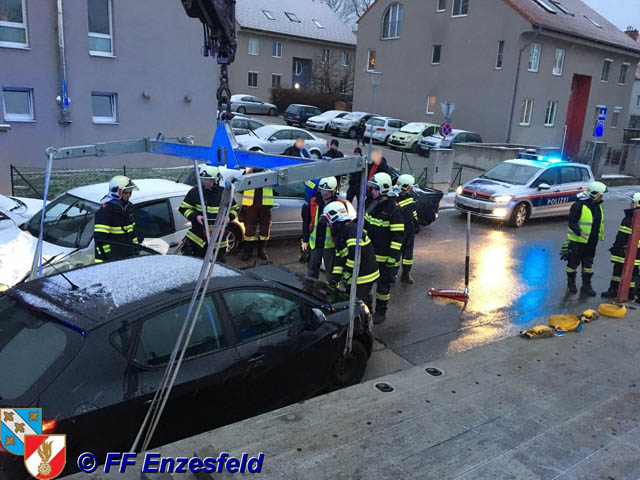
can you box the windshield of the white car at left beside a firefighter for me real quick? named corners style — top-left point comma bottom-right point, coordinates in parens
top-left (26, 193), bottom-right (100, 248)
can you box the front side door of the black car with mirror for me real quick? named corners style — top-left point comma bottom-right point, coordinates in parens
top-left (221, 288), bottom-right (331, 411)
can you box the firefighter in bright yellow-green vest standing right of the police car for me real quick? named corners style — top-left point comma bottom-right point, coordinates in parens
top-left (567, 182), bottom-right (607, 297)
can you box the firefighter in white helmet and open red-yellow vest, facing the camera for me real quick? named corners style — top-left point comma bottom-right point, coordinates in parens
top-left (302, 177), bottom-right (344, 278)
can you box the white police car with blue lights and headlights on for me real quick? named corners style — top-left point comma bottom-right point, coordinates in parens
top-left (455, 153), bottom-right (594, 227)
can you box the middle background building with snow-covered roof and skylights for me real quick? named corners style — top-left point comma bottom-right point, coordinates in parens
top-left (229, 0), bottom-right (356, 101)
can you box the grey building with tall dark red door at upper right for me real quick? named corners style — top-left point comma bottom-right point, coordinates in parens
top-left (354, 0), bottom-right (640, 157)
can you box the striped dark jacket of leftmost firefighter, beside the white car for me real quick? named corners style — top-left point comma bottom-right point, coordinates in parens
top-left (93, 199), bottom-right (143, 263)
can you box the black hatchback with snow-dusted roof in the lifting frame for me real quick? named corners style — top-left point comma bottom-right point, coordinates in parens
top-left (0, 256), bottom-right (373, 480)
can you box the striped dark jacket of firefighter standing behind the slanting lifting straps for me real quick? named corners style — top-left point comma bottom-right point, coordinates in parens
top-left (178, 186), bottom-right (238, 248)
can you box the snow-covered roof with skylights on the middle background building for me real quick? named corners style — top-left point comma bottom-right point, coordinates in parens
top-left (236, 0), bottom-right (356, 47)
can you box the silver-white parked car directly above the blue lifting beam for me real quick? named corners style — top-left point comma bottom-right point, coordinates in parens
top-left (236, 125), bottom-right (329, 159)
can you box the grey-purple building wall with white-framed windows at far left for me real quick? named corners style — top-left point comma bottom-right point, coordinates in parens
top-left (0, 0), bottom-right (218, 194)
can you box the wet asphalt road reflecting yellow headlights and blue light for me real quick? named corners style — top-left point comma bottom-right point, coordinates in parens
top-left (229, 187), bottom-right (640, 371)
